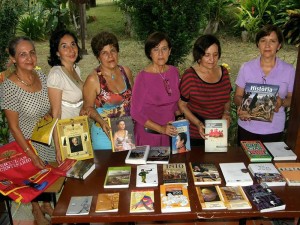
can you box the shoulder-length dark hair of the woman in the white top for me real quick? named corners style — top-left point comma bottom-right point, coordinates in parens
top-left (48, 30), bottom-right (82, 66)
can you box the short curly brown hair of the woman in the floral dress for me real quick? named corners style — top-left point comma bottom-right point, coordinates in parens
top-left (91, 31), bottom-right (119, 58)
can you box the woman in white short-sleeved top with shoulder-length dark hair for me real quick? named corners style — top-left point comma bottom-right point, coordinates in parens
top-left (47, 30), bottom-right (83, 163)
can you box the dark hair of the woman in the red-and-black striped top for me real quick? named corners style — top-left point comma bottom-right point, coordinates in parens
top-left (193, 34), bottom-right (221, 62)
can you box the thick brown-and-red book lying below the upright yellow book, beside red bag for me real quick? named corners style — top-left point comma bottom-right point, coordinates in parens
top-left (57, 158), bottom-right (96, 180)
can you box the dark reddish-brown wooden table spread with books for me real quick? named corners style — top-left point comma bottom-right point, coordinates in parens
top-left (51, 147), bottom-right (300, 224)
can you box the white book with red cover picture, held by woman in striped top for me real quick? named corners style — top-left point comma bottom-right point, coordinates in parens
top-left (204, 120), bottom-right (228, 152)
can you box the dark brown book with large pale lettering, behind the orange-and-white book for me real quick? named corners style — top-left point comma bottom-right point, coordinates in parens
top-left (163, 163), bottom-right (188, 185)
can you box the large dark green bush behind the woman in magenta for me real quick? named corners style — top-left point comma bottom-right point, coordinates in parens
top-left (117, 0), bottom-right (206, 65)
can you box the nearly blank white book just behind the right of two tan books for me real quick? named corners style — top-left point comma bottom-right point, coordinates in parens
top-left (219, 162), bottom-right (253, 186)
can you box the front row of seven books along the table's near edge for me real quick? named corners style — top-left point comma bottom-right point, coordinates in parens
top-left (66, 184), bottom-right (286, 215)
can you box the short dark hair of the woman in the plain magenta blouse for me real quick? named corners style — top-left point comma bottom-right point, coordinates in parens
top-left (145, 31), bottom-right (172, 60)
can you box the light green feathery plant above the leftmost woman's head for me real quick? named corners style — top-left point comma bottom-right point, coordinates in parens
top-left (18, 4), bottom-right (46, 40)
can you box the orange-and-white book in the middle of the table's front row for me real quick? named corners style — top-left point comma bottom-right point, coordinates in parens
top-left (160, 184), bottom-right (191, 213)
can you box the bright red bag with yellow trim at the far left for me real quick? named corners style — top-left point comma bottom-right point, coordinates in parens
top-left (0, 141), bottom-right (60, 203)
